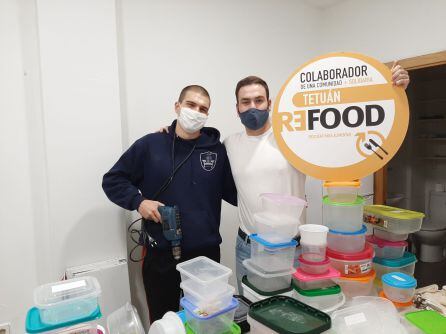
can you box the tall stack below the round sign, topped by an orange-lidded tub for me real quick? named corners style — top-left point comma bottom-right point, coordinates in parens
top-left (323, 181), bottom-right (376, 298)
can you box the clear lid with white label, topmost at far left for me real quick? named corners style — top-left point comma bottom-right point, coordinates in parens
top-left (34, 276), bottom-right (101, 308)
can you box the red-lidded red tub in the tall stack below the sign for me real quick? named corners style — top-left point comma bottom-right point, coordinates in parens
top-left (327, 243), bottom-right (374, 277)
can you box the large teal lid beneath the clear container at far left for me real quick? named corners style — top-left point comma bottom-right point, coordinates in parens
top-left (25, 306), bottom-right (102, 333)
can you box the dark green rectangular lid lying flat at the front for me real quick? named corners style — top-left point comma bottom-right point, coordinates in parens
top-left (249, 296), bottom-right (331, 334)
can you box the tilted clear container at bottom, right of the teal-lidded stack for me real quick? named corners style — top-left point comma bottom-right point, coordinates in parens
top-left (107, 303), bottom-right (145, 334)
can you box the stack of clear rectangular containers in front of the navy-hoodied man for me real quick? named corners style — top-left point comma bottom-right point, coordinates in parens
top-left (177, 256), bottom-right (238, 334)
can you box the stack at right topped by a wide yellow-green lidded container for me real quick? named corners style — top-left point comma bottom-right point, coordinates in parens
top-left (364, 205), bottom-right (424, 285)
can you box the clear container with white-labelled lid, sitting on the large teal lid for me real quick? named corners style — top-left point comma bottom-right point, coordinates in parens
top-left (34, 276), bottom-right (101, 324)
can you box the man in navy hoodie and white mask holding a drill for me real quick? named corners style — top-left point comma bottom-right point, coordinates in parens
top-left (102, 85), bottom-right (237, 322)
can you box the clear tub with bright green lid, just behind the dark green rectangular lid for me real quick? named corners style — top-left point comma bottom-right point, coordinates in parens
top-left (293, 283), bottom-right (345, 313)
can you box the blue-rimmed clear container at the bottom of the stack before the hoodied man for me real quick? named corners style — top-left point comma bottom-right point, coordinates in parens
top-left (180, 298), bottom-right (238, 334)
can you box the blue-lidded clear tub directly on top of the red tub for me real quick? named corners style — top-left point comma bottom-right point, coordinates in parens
top-left (327, 225), bottom-right (367, 253)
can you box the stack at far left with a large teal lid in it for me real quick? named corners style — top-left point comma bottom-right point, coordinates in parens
top-left (26, 277), bottom-right (105, 334)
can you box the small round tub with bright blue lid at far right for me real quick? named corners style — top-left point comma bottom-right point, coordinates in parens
top-left (381, 272), bottom-right (417, 303)
